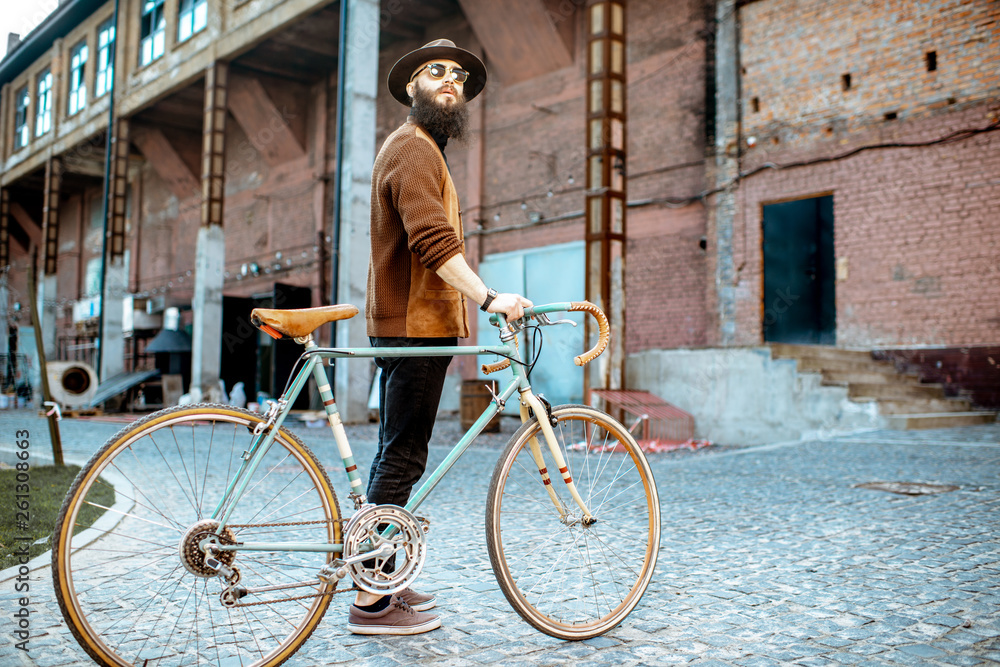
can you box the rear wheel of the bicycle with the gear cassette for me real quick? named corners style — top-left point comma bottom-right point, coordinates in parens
top-left (52, 404), bottom-right (342, 666)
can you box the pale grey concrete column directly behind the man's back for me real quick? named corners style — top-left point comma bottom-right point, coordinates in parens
top-left (334, 0), bottom-right (381, 422)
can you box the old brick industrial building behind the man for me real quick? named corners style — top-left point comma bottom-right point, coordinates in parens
top-left (0, 0), bottom-right (1000, 442)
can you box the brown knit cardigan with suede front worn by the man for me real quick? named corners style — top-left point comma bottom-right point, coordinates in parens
top-left (365, 120), bottom-right (469, 338)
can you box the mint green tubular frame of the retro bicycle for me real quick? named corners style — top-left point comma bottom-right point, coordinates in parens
top-left (211, 302), bottom-right (590, 553)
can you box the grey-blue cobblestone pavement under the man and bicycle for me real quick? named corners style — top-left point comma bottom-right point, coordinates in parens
top-left (0, 412), bottom-right (1000, 667)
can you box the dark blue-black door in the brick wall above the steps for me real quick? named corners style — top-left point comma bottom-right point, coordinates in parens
top-left (763, 196), bottom-right (837, 345)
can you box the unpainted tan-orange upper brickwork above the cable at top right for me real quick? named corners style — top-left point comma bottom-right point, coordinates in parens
top-left (740, 0), bottom-right (1000, 149)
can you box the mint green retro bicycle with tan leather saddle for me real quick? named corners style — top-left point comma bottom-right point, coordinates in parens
top-left (52, 302), bottom-right (660, 666)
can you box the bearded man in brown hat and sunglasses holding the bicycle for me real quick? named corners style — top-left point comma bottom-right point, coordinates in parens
top-left (347, 39), bottom-right (532, 635)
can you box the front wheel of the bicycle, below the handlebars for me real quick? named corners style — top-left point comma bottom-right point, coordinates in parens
top-left (486, 405), bottom-right (660, 640)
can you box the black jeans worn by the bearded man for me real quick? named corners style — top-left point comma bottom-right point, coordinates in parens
top-left (367, 338), bottom-right (458, 507)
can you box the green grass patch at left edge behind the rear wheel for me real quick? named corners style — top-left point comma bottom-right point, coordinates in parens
top-left (0, 466), bottom-right (115, 570)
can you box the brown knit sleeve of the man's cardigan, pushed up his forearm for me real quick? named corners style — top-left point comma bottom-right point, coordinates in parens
top-left (384, 137), bottom-right (462, 271)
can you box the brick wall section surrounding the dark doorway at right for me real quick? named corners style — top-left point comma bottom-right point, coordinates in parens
top-left (733, 0), bottom-right (1000, 347)
